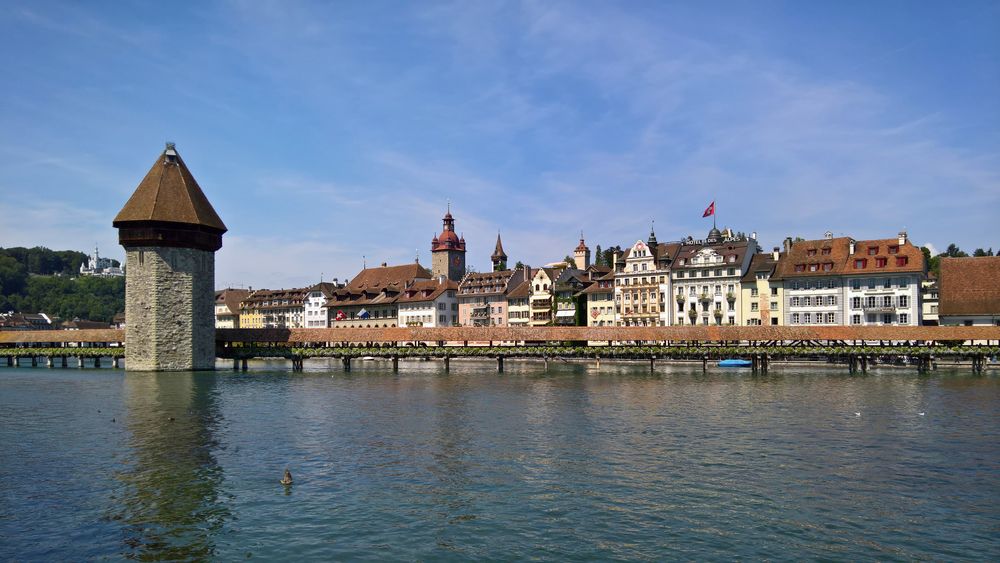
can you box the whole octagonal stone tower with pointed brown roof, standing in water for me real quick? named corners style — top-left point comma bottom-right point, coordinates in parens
top-left (113, 143), bottom-right (227, 371)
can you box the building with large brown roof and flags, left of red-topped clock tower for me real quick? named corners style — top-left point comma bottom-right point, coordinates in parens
top-left (326, 262), bottom-right (432, 328)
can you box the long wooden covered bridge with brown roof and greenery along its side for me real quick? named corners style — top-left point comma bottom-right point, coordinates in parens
top-left (0, 326), bottom-right (1000, 372)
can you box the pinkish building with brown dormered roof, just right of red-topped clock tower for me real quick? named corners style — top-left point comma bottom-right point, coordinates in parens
top-left (458, 268), bottom-right (531, 326)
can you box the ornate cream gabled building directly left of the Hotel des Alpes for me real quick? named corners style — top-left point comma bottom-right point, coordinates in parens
top-left (615, 230), bottom-right (681, 326)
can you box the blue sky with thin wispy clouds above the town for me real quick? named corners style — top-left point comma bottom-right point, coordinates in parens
top-left (0, 0), bottom-right (1000, 287)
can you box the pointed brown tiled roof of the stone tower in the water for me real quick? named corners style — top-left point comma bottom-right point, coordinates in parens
top-left (113, 148), bottom-right (228, 233)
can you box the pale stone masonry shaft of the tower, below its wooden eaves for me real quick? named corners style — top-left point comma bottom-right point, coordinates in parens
top-left (125, 247), bottom-right (215, 371)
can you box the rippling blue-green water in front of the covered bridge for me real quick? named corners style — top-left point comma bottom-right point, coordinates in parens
top-left (0, 360), bottom-right (1000, 561)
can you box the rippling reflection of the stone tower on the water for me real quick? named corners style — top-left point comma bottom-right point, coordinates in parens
top-left (112, 373), bottom-right (230, 560)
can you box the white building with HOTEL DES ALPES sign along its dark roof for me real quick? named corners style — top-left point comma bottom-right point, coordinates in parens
top-left (667, 227), bottom-right (757, 325)
